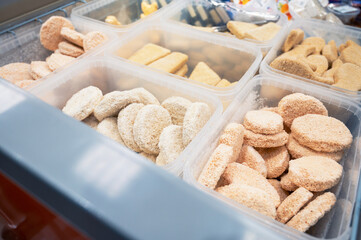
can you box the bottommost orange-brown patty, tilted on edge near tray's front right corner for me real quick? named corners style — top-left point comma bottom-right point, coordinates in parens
top-left (287, 192), bottom-right (336, 232)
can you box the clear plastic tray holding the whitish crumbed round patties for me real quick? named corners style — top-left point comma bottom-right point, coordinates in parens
top-left (30, 57), bottom-right (223, 175)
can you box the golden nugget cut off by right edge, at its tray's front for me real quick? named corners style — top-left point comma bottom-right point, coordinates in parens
top-left (333, 62), bottom-right (361, 91)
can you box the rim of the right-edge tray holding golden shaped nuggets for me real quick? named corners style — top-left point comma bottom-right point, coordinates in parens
top-left (260, 18), bottom-right (361, 100)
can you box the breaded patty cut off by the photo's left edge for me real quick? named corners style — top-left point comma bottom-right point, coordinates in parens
top-left (0, 63), bottom-right (33, 83)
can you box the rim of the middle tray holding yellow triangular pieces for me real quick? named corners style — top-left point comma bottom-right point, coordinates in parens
top-left (105, 21), bottom-right (263, 98)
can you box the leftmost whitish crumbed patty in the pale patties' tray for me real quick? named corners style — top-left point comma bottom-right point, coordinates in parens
top-left (62, 86), bottom-right (103, 121)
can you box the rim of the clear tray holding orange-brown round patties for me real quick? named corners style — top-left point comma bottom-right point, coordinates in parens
top-left (183, 74), bottom-right (361, 240)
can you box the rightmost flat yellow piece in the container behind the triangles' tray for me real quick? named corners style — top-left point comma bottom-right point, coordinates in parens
top-left (244, 22), bottom-right (281, 41)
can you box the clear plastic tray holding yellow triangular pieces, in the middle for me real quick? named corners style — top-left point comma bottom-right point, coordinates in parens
top-left (106, 22), bottom-right (262, 101)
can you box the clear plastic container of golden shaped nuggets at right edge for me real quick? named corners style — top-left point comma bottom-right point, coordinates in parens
top-left (260, 20), bottom-right (361, 99)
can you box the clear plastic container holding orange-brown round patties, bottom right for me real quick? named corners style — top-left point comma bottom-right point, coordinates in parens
top-left (184, 75), bottom-right (361, 239)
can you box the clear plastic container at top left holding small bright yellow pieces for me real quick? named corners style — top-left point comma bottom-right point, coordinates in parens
top-left (71, 0), bottom-right (177, 34)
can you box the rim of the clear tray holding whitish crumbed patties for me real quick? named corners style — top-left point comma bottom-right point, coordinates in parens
top-left (30, 56), bottom-right (223, 176)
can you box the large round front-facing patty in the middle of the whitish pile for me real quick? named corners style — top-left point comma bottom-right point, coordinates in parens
top-left (133, 104), bottom-right (172, 154)
